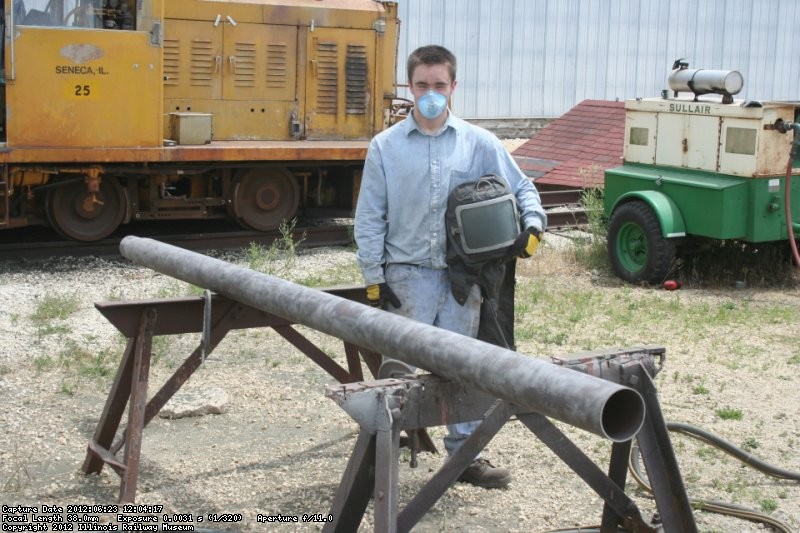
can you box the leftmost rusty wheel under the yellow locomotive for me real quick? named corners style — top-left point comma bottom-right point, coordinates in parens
top-left (45, 176), bottom-right (125, 242)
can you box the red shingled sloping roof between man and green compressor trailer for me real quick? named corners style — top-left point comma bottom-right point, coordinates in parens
top-left (512, 100), bottom-right (625, 188)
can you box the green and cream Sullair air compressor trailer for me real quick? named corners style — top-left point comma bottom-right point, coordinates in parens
top-left (604, 62), bottom-right (800, 283)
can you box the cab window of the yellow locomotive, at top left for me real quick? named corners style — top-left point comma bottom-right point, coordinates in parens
top-left (14, 0), bottom-right (136, 30)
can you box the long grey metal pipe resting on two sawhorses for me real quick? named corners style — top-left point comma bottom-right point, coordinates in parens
top-left (120, 236), bottom-right (644, 442)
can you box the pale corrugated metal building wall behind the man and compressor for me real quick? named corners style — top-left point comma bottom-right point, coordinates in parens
top-left (397, 0), bottom-right (800, 118)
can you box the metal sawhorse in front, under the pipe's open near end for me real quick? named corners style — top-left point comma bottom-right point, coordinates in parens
top-left (323, 346), bottom-right (697, 533)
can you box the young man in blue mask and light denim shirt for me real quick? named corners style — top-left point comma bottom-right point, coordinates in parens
top-left (355, 45), bottom-right (547, 488)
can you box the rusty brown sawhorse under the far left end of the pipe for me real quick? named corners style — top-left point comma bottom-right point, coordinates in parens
top-left (82, 287), bottom-right (436, 503)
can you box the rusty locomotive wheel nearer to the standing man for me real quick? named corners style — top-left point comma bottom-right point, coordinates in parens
top-left (231, 168), bottom-right (300, 231)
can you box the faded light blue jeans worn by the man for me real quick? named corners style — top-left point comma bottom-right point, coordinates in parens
top-left (385, 264), bottom-right (481, 455)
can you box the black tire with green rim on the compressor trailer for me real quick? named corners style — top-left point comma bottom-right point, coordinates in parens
top-left (608, 201), bottom-right (675, 283)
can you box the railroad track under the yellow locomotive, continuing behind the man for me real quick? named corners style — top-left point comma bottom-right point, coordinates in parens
top-left (0, 190), bottom-right (587, 261)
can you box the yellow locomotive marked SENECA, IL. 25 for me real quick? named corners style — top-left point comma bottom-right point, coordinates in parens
top-left (0, 0), bottom-right (399, 241)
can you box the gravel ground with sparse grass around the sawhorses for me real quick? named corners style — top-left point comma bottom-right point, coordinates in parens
top-left (0, 238), bottom-right (800, 532)
